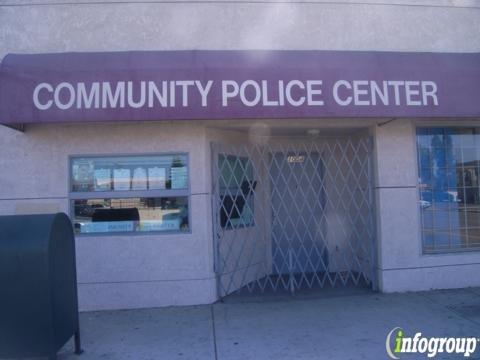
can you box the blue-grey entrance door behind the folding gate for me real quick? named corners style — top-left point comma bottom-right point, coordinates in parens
top-left (270, 152), bottom-right (328, 291)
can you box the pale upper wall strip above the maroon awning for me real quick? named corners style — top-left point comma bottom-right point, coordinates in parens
top-left (0, 0), bottom-right (480, 58)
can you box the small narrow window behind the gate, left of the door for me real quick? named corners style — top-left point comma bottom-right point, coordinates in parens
top-left (218, 154), bottom-right (256, 229)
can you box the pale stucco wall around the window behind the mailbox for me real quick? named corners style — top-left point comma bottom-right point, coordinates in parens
top-left (0, 122), bottom-right (216, 310)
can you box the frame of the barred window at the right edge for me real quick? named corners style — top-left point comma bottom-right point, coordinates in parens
top-left (412, 125), bottom-right (480, 257)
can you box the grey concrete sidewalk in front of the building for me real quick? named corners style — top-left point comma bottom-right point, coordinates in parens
top-left (54, 288), bottom-right (480, 360)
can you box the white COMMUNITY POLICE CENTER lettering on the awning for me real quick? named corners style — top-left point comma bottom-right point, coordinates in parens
top-left (33, 79), bottom-right (439, 110)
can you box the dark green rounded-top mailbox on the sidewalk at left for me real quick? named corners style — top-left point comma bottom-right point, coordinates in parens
top-left (0, 213), bottom-right (82, 359)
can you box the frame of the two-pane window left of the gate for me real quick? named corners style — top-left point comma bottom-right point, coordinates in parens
top-left (67, 151), bottom-right (192, 237)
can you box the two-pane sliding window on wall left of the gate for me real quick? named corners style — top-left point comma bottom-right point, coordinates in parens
top-left (70, 154), bottom-right (189, 234)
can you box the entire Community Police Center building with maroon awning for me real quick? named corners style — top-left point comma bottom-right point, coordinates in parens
top-left (0, 0), bottom-right (480, 310)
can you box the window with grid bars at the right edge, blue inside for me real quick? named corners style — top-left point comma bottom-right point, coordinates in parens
top-left (417, 128), bottom-right (480, 253)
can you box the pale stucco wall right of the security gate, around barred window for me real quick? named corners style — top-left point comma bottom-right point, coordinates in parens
top-left (375, 120), bottom-right (480, 292)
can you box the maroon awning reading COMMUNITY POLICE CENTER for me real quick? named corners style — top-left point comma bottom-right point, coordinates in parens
top-left (0, 51), bottom-right (480, 124)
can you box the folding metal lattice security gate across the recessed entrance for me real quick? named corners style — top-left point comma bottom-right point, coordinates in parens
top-left (212, 137), bottom-right (376, 297)
